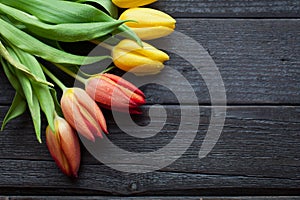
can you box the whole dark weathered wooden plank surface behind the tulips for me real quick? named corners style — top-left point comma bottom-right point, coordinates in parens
top-left (0, 0), bottom-right (300, 199)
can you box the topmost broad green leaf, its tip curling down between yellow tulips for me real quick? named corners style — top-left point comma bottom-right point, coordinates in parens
top-left (0, 0), bottom-right (141, 45)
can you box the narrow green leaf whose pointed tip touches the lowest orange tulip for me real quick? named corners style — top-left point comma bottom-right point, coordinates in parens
top-left (14, 48), bottom-right (55, 132)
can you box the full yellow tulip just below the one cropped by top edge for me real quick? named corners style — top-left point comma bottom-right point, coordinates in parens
top-left (119, 8), bottom-right (176, 40)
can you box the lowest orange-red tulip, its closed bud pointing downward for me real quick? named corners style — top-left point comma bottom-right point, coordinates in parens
top-left (46, 116), bottom-right (80, 177)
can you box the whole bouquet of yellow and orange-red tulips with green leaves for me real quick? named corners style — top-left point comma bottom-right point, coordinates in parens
top-left (0, 0), bottom-right (176, 177)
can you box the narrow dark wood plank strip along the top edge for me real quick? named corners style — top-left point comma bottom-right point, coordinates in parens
top-left (151, 0), bottom-right (300, 18)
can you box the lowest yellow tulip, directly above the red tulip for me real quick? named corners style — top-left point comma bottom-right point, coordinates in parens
top-left (112, 39), bottom-right (169, 75)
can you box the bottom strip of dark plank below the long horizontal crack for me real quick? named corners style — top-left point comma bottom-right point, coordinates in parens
top-left (0, 160), bottom-right (300, 195)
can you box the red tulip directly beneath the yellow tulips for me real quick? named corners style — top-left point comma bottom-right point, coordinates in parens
top-left (85, 73), bottom-right (145, 114)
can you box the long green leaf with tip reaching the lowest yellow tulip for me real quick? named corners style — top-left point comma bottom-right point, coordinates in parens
top-left (0, 19), bottom-right (110, 65)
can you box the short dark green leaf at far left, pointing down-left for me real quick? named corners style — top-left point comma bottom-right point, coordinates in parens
top-left (1, 92), bottom-right (26, 131)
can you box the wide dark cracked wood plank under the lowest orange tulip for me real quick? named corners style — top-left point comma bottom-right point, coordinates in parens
top-left (0, 106), bottom-right (300, 195)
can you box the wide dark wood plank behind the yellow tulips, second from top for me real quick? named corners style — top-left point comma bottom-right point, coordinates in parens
top-left (0, 19), bottom-right (300, 104)
